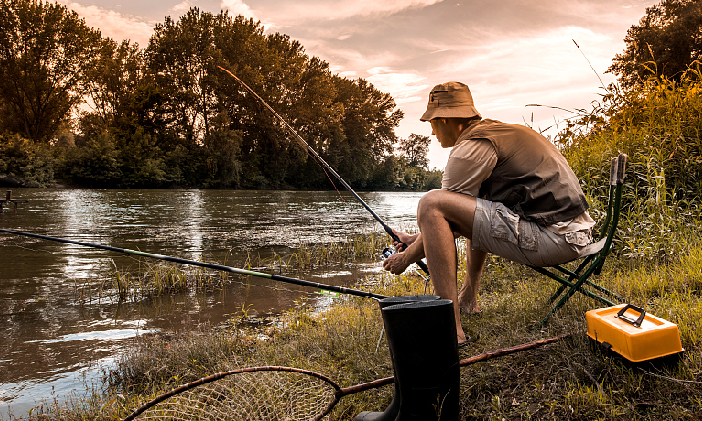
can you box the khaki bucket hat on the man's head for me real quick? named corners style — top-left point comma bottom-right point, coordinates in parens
top-left (420, 82), bottom-right (480, 121)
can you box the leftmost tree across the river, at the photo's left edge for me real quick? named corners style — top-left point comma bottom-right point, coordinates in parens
top-left (0, 0), bottom-right (100, 143)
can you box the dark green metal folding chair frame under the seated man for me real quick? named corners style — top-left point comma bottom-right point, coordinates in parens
top-left (529, 154), bottom-right (627, 329)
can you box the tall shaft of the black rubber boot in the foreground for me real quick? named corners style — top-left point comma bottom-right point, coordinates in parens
top-left (374, 300), bottom-right (460, 421)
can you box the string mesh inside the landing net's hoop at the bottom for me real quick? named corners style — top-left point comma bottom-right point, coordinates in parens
top-left (136, 371), bottom-right (335, 421)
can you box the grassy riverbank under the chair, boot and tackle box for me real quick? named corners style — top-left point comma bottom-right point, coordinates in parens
top-left (19, 241), bottom-right (702, 420)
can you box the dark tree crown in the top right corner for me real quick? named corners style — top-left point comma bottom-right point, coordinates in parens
top-left (608, 0), bottom-right (702, 89)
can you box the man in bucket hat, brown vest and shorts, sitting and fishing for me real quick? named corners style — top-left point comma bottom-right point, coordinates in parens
top-left (383, 82), bottom-right (602, 346)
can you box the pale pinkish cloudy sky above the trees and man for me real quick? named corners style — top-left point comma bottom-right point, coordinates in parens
top-left (58, 0), bottom-right (658, 169)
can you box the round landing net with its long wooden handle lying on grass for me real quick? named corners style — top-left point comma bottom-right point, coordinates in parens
top-left (124, 334), bottom-right (571, 421)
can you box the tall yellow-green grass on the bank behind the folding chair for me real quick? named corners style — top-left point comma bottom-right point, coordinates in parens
top-left (557, 65), bottom-right (702, 259)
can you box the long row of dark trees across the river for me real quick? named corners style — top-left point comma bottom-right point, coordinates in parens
top-left (0, 0), bottom-right (441, 190)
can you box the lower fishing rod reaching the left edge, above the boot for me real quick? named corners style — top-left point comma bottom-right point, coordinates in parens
top-left (0, 229), bottom-right (387, 300)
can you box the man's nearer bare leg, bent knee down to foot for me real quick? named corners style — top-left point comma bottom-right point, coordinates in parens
top-left (410, 190), bottom-right (476, 343)
